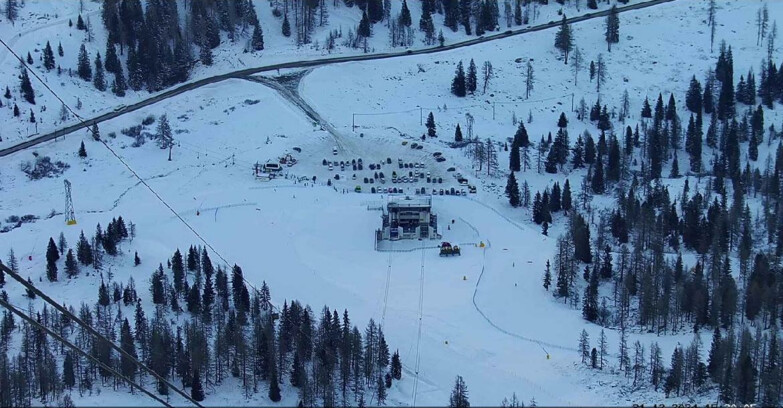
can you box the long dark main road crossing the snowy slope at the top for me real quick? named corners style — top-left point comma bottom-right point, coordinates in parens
top-left (0, 0), bottom-right (674, 157)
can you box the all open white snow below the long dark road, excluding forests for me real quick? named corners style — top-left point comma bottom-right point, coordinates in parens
top-left (0, 0), bottom-right (781, 406)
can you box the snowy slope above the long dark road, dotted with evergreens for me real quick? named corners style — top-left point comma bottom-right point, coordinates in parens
top-left (0, 0), bottom-right (637, 148)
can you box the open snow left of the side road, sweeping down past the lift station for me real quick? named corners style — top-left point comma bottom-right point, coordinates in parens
top-left (0, 80), bottom-right (712, 405)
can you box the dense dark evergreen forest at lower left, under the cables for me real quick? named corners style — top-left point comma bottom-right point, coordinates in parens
top-left (0, 217), bottom-right (402, 406)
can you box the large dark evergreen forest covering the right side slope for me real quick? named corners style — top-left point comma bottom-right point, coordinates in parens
top-left (496, 12), bottom-right (783, 405)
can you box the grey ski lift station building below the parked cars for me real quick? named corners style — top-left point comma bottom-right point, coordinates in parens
top-left (376, 196), bottom-right (440, 241)
